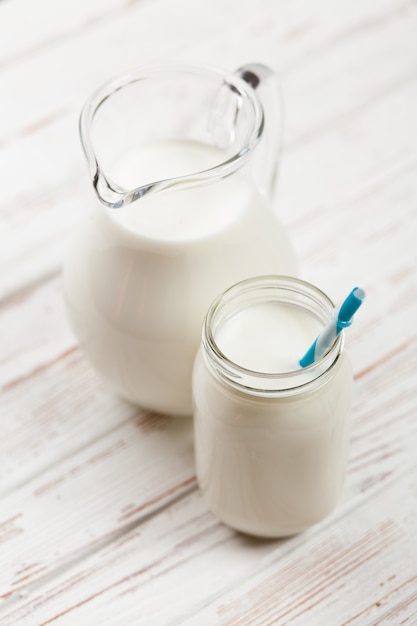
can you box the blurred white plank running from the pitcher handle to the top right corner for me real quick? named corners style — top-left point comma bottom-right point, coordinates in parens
top-left (282, 4), bottom-right (417, 144)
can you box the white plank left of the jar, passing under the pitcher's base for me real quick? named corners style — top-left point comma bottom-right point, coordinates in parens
top-left (0, 414), bottom-right (196, 599)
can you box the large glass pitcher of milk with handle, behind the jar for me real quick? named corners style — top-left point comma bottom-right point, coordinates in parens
top-left (64, 64), bottom-right (296, 415)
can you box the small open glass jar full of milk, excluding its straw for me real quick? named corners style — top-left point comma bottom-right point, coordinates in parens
top-left (193, 276), bottom-right (352, 537)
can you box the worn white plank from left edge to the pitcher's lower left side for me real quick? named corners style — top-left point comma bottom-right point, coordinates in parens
top-left (0, 349), bottom-right (136, 494)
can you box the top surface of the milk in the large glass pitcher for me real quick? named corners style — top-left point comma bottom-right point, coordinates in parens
top-left (110, 140), bottom-right (252, 243)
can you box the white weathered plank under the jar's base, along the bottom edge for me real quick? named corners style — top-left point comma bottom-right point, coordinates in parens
top-left (0, 454), bottom-right (417, 626)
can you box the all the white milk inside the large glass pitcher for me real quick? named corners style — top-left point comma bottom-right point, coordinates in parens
top-left (64, 140), bottom-right (295, 415)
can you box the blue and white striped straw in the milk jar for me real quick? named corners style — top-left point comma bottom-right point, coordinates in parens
top-left (299, 287), bottom-right (365, 367)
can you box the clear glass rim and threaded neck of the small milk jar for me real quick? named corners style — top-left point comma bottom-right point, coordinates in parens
top-left (202, 276), bottom-right (343, 397)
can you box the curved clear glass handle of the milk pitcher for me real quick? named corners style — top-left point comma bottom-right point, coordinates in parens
top-left (235, 63), bottom-right (283, 199)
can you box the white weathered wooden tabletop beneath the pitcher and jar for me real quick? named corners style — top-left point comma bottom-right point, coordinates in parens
top-left (0, 0), bottom-right (417, 626)
